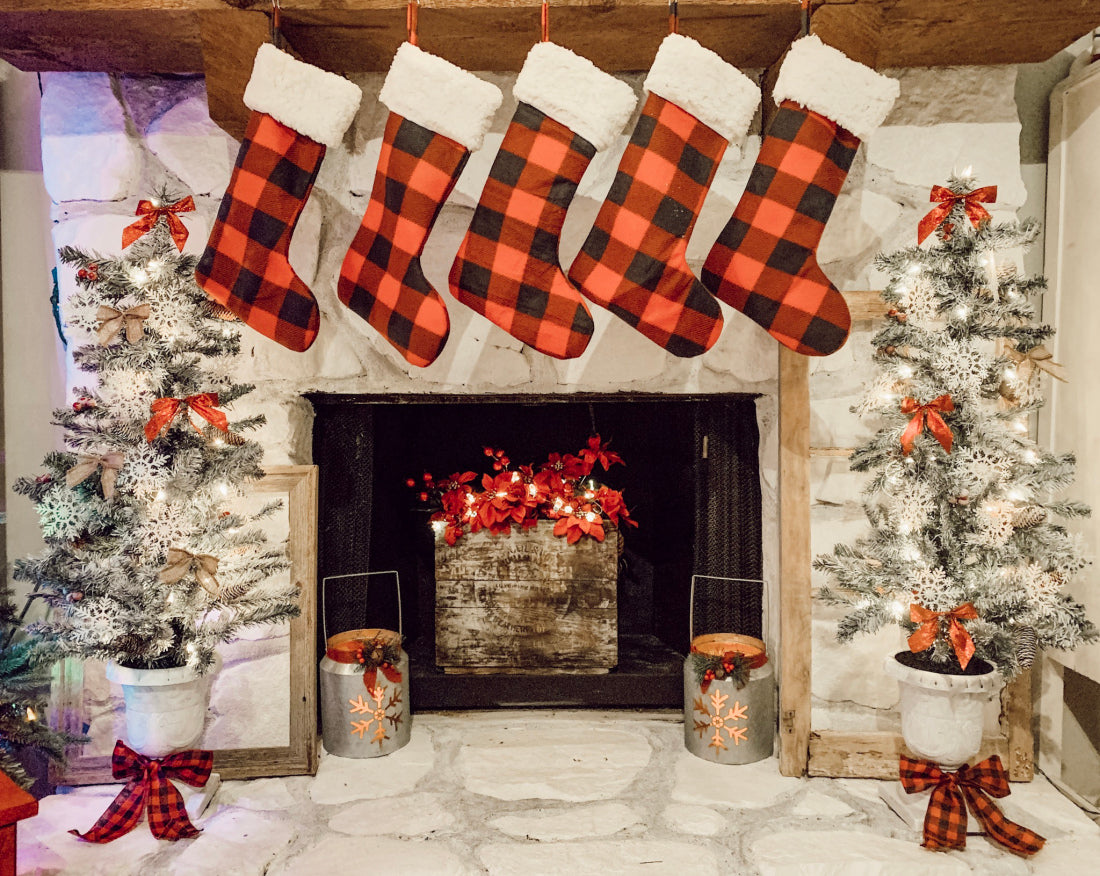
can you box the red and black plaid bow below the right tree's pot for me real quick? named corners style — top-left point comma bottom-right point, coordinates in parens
top-left (899, 754), bottom-right (1046, 855)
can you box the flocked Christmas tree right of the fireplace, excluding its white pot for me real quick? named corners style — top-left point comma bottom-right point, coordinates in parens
top-left (815, 177), bottom-right (1097, 678)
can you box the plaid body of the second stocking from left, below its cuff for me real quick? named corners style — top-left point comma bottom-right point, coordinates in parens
top-left (338, 112), bottom-right (470, 366)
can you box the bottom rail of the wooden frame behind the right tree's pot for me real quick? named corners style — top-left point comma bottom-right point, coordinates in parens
top-left (809, 730), bottom-right (1008, 780)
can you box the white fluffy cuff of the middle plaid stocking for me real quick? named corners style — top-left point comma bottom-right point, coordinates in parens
top-left (512, 43), bottom-right (638, 151)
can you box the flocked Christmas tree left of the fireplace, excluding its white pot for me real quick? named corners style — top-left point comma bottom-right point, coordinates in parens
top-left (15, 197), bottom-right (298, 672)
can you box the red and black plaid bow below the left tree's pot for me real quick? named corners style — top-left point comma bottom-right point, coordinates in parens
top-left (69, 740), bottom-right (213, 843)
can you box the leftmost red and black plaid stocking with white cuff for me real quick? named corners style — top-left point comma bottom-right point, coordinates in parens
top-left (195, 44), bottom-right (362, 352)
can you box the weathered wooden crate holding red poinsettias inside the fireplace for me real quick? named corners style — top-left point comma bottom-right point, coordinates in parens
top-left (436, 521), bottom-right (618, 674)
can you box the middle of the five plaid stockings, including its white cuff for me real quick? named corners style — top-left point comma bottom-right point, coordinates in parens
top-left (450, 43), bottom-right (636, 359)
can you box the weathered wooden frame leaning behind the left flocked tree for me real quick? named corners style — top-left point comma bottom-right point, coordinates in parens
top-left (50, 466), bottom-right (319, 785)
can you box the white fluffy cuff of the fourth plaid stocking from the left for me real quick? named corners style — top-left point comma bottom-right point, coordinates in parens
top-left (642, 33), bottom-right (760, 146)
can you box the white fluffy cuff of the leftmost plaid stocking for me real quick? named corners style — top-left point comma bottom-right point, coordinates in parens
top-left (244, 43), bottom-right (363, 146)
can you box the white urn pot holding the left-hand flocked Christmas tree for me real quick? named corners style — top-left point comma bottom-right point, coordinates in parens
top-left (107, 658), bottom-right (221, 757)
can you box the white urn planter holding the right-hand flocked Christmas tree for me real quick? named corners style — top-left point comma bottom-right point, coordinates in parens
top-left (880, 654), bottom-right (1003, 830)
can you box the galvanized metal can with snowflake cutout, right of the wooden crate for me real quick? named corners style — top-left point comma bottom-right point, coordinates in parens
top-left (684, 580), bottom-right (776, 764)
